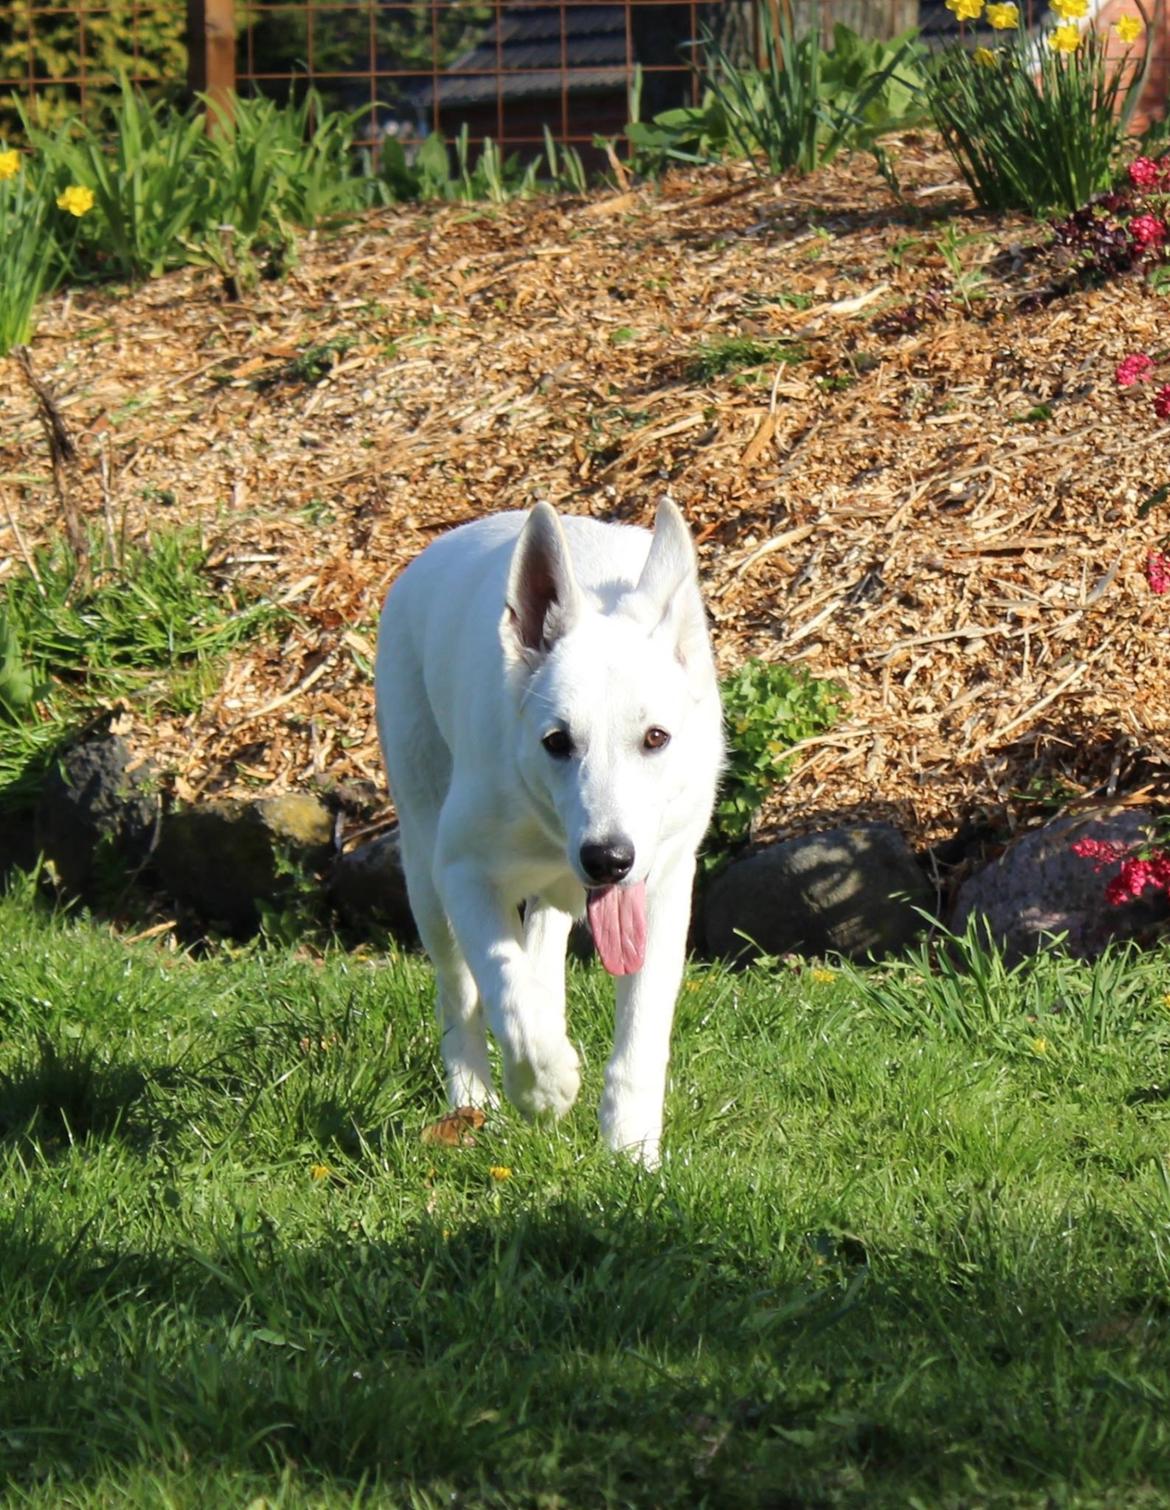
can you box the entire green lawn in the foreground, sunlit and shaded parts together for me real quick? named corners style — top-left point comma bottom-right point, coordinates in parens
top-left (0, 888), bottom-right (1170, 1507)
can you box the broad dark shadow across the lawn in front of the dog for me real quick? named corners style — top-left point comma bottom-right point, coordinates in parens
top-left (0, 1176), bottom-right (1170, 1507)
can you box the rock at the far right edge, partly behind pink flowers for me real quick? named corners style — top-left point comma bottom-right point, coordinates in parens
top-left (951, 808), bottom-right (1170, 960)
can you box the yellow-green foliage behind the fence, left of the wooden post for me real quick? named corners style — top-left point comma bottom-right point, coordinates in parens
top-left (0, 0), bottom-right (187, 128)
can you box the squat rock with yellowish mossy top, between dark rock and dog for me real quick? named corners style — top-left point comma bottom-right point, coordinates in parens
top-left (155, 793), bottom-right (334, 933)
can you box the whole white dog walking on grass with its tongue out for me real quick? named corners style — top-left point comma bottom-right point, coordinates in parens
top-left (374, 500), bottom-right (723, 1164)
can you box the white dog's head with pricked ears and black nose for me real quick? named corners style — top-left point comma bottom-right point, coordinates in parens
top-left (501, 500), bottom-right (720, 942)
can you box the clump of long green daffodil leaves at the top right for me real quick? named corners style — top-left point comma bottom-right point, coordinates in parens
top-left (924, 16), bottom-right (1150, 214)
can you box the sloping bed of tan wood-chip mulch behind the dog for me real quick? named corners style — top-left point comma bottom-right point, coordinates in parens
top-left (0, 139), bottom-right (1170, 863)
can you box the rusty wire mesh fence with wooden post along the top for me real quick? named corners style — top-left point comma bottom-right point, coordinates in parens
top-left (0, 0), bottom-right (1170, 149)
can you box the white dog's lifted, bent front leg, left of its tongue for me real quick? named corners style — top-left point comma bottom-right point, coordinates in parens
top-left (438, 861), bottom-right (581, 1117)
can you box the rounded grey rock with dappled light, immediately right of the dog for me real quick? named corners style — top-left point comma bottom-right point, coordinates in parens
top-left (704, 823), bottom-right (934, 960)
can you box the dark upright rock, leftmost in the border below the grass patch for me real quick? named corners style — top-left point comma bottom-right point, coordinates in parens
top-left (33, 732), bottom-right (162, 900)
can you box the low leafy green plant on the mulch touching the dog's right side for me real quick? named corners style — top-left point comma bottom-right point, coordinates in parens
top-left (707, 658), bottom-right (845, 868)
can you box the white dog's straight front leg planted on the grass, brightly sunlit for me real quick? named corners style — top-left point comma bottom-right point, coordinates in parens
top-left (601, 859), bottom-right (694, 1169)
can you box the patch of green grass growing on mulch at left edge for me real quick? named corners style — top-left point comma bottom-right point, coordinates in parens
top-left (0, 530), bottom-right (275, 808)
